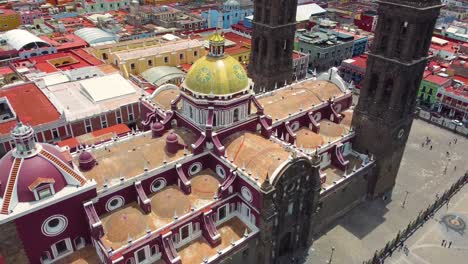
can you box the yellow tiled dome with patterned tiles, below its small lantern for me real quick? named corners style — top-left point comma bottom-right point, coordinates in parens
top-left (184, 55), bottom-right (249, 95)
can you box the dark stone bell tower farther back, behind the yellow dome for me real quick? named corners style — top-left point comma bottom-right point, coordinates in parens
top-left (249, 0), bottom-right (297, 92)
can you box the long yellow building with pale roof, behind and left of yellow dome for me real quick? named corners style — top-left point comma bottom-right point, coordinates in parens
top-left (89, 38), bottom-right (206, 78)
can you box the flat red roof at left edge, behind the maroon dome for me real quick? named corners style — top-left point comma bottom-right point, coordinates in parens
top-left (0, 83), bottom-right (60, 134)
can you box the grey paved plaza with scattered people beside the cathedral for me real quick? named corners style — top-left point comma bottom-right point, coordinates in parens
top-left (299, 120), bottom-right (468, 264)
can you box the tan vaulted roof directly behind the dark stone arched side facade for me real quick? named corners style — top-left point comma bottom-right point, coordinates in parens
top-left (223, 132), bottom-right (289, 183)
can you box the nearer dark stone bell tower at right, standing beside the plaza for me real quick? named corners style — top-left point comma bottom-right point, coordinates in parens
top-left (352, 0), bottom-right (442, 196)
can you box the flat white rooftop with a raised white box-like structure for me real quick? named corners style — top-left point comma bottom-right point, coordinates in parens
top-left (44, 73), bottom-right (141, 121)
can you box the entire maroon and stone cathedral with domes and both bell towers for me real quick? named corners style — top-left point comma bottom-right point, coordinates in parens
top-left (0, 0), bottom-right (441, 264)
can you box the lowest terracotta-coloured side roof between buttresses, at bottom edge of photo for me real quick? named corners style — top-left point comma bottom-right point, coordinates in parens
top-left (178, 217), bottom-right (251, 263)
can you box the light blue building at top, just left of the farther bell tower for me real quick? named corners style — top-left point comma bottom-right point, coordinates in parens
top-left (202, 0), bottom-right (253, 29)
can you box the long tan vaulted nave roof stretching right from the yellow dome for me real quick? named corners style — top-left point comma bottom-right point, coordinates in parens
top-left (259, 80), bottom-right (343, 121)
